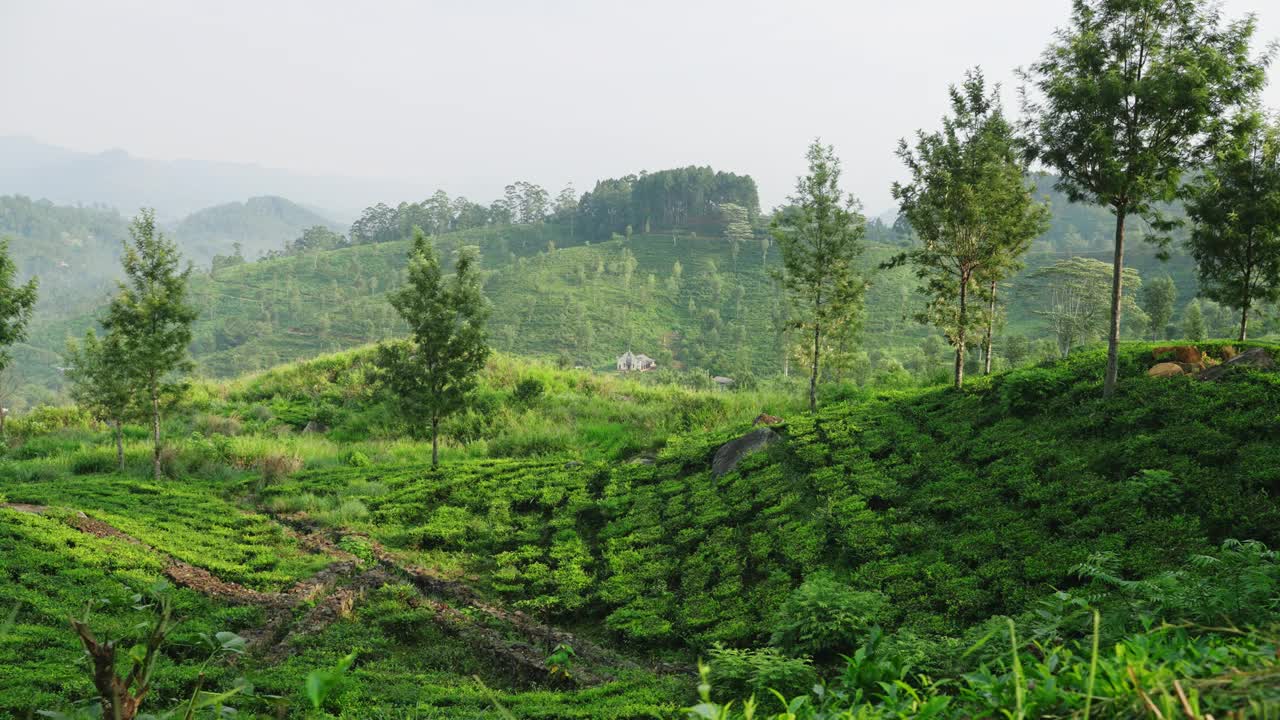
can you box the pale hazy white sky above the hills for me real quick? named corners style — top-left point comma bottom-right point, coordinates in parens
top-left (0, 0), bottom-right (1280, 213)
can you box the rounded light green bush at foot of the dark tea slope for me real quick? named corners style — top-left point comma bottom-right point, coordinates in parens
top-left (769, 575), bottom-right (884, 661)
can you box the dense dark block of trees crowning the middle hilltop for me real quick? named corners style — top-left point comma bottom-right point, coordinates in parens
top-left (577, 165), bottom-right (760, 237)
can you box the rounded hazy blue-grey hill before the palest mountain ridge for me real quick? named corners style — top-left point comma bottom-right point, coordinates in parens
top-left (169, 196), bottom-right (347, 264)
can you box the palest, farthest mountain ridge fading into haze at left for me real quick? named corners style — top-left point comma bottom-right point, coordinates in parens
top-left (0, 137), bottom-right (430, 222)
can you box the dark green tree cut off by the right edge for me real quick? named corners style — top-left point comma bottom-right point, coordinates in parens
top-left (1187, 113), bottom-right (1280, 342)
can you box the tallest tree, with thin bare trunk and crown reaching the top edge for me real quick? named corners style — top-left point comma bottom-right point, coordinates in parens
top-left (1023, 0), bottom-right (1266, 395)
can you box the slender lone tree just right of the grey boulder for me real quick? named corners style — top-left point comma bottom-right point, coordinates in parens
top-left (772, 140), bottom-right (867, 413)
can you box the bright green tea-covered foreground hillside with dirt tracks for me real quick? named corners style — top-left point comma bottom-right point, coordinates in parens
top-left (0, 343), bottom-right (1280, 719)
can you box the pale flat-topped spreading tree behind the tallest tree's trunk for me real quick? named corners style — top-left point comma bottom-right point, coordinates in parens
top-left (1024, 258), bottom-right (1142, 357)
